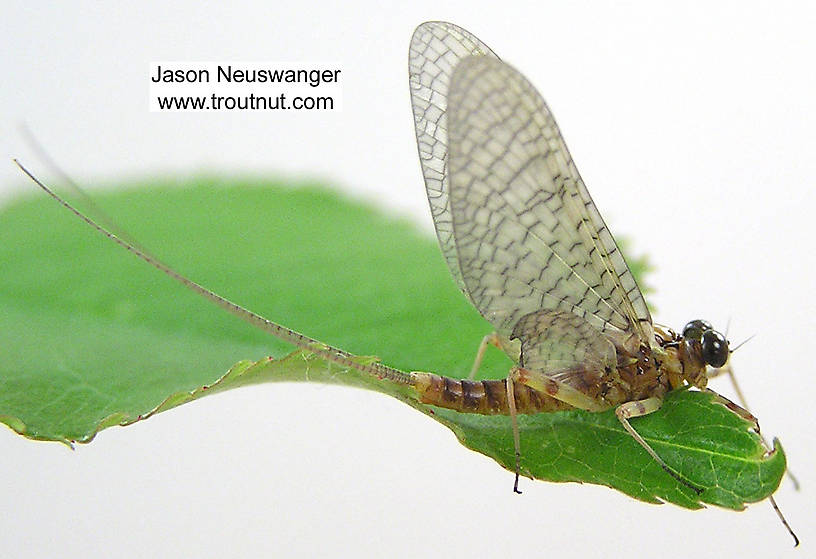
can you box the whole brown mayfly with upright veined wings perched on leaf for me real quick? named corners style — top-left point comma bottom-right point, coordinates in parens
top-left (11, 22), bottom-right (798, 543)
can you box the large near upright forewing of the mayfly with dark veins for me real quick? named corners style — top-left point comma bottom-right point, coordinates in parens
top-left (448, 56), bottom-right (653, 350)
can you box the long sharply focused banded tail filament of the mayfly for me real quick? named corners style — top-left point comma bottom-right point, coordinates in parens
top-left (14, 159), bottom-right (415, 386)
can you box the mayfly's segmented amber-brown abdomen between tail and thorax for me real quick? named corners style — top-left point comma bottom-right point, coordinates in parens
top-left (411, 373), bottom-right (574, 415)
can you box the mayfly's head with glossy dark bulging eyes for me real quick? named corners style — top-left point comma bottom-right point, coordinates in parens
top-left (680, 320), bottom-right (731, 388)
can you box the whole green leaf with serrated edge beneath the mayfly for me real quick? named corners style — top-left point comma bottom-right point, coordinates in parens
top-left (0, 180), bottom-right (785, 509)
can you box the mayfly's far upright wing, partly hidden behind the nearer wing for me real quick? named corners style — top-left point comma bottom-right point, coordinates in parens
top-left (408, 21), bottom-right (498, 297)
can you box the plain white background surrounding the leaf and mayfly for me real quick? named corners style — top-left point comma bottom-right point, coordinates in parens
top-left (0, 0), bottom-right (816, 557)
